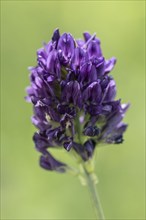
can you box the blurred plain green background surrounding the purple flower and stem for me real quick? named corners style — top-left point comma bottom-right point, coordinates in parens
top-left (1, 0), bottom-right (145, 220)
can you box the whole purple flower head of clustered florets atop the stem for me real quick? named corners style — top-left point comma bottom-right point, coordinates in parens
top-left (26, 29), bottom-right (129, 172)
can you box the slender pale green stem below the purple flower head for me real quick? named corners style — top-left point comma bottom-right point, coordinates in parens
top-left (84, 168), bottom-right (105, 220)
